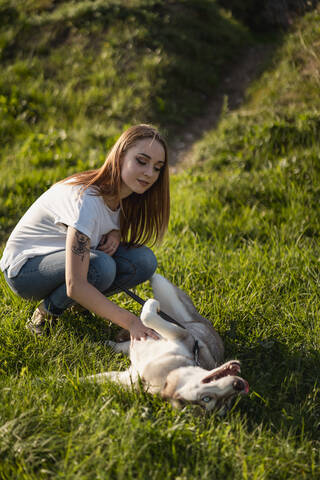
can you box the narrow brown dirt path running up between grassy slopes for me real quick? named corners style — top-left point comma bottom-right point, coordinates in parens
top-left (169, 45), bottom-right (275, 173)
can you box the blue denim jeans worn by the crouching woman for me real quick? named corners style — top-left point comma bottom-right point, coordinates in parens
top-left (4, 245), bottom-right (157, 315)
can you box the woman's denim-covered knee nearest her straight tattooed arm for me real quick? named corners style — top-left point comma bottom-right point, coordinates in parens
top-left (88, 251), bottom-right (117, 292)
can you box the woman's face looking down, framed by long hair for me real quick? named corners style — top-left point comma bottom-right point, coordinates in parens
top-left (120, 138), bottom-right (165, 198)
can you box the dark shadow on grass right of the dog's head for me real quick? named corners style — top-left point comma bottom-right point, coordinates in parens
top-left (224, 332), bottom-right (320, 440)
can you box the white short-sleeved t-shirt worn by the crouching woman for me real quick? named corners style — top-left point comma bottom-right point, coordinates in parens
top-left (0, 182), bottom-right (120, 278)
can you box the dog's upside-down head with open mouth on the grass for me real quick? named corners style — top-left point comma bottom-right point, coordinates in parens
top-left (162, 360), bottom-right (249, 412)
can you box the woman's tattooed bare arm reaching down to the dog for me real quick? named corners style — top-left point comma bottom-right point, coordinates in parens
top-left (66, 227), bottom-right (158, 340)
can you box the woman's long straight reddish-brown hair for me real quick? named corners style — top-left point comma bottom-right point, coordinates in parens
top-left (63, 124), bottom-right (170, 246)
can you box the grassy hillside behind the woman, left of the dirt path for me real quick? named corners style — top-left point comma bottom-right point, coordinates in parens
top-left (0, 0), bottom-right (252, 240)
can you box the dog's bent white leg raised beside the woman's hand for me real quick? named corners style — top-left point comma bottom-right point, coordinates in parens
top-left (140, 299), bottom-right (189, 340)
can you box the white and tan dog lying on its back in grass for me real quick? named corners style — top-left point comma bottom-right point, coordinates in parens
top-left (87, 274), bottom-right (249, 411)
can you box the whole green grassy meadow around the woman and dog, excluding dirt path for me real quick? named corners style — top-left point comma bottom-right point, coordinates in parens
top-left (0, 0), bottom-right (320, 480)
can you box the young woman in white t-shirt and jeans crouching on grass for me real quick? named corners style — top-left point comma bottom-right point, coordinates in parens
top-left (0, 125), bottom-right (170, 339)
